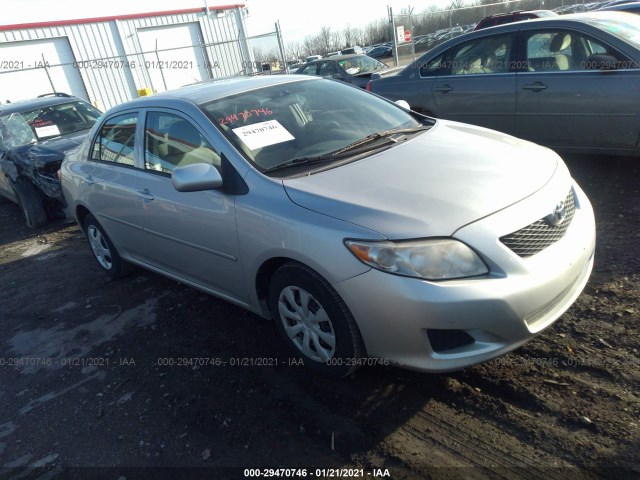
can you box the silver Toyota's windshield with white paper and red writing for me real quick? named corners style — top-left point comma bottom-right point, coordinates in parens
top-left (202, 80), bottom-right (422, 171)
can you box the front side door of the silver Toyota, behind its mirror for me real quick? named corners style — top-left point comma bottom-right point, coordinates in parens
top-left (135, 110), bottom-right (247, 301)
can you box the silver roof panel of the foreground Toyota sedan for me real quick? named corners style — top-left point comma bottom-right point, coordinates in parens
top-left (114, 75), bottom-right (321, 110)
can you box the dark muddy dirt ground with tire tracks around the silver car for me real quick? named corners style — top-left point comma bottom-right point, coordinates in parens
top-left (0, 157), bottom-right (640, 480)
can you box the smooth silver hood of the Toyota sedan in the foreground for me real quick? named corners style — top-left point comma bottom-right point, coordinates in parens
top-left (283, 120), bottom-right (560, 239)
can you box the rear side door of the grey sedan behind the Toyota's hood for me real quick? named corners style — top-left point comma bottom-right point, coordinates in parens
top-left (430, 33), bottom-right (516, 133)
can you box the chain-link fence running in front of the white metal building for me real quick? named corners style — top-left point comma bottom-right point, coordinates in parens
top-left (0, 29), bottom-right (286, 109)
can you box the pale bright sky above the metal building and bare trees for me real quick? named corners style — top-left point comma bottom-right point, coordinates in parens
top-left (0, 0), bottom-right (449, 43)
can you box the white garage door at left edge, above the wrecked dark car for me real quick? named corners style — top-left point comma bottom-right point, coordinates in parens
top-left (0, 37), bottom-right (88, 102)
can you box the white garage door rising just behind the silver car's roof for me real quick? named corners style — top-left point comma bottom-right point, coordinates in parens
top-left (138, 22), bottom-right (209, 92)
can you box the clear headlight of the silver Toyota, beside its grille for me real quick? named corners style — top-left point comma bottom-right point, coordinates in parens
top-left (345, 238), bottom-right (489, 280)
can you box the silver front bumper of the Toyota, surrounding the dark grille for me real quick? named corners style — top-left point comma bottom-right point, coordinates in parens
top-left (334, 180), bottom-right (595, 372)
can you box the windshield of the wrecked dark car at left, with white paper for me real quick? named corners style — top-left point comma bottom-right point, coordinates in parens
top-left (0, 102), bottom-right (101, 148)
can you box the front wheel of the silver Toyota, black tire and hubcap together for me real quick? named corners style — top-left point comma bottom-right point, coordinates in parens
top-left (269, 263), bottom-right (364, 378)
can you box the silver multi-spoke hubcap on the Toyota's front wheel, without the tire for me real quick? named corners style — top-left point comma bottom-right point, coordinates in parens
top-left (278, 286), bottom-right (336, 362)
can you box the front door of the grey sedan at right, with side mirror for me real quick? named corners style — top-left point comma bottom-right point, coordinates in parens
top-left (516, 28), bottom-right (640, 148)
